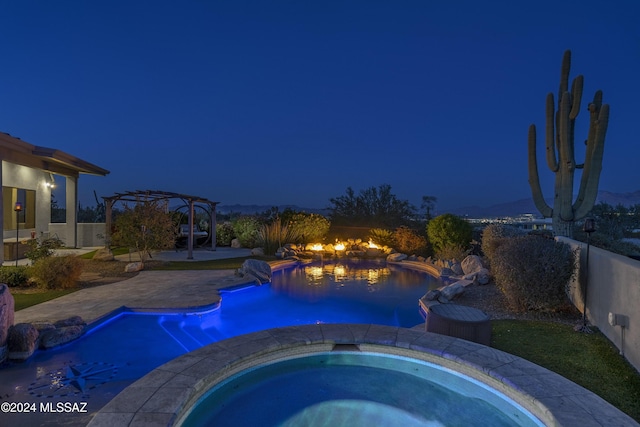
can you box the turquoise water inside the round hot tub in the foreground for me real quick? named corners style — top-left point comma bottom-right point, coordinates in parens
top-left (181, 352), bottom-right (541, 427)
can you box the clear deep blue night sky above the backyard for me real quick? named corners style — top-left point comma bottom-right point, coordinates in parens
top-left (0, 0), bottom-right (640, 209)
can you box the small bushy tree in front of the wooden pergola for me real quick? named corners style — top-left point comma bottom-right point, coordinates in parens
top-left (113, 200), bottom-right (177, 263)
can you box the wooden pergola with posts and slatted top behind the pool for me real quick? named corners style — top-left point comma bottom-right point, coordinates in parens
top-left (102, 190), bottom-right (219, 259)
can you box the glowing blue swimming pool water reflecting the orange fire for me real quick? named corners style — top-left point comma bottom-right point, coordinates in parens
top-left (0, 261), bottom-right (441, 411)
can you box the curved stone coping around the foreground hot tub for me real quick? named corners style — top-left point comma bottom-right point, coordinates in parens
top-left (89, 324), bottom-right (639, 427)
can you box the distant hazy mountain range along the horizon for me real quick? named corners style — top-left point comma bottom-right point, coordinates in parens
top-left (216, 190), bottom-right (640, 218)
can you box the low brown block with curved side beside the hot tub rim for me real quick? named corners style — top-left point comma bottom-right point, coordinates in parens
top-left (421, 301), bottom-right (491, 345)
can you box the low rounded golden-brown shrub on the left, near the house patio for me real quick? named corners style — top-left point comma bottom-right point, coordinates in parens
top-left (31, 255), bottom-right (82, 289)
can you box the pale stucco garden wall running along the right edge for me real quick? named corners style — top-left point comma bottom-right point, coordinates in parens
top-left (558, 237), bottom-right (640, 371)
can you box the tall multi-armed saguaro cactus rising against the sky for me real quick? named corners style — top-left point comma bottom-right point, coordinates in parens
top-left (529, 50), bottom-right (609, 237)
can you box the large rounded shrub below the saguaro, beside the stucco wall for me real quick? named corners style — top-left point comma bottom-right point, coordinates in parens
top-left (491, 235), bottom-right (576, 312)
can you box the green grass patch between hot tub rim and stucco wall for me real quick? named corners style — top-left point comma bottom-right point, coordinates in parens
top-left (491, 320), bottom-right (640, 422)
